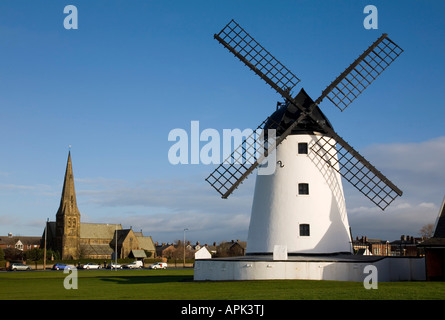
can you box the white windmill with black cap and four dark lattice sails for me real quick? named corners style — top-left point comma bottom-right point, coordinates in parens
top-left (206, 20), bottom-right (403, 254)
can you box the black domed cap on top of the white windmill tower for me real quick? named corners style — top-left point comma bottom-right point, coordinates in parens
top-left (264, 89), bottom-right (332, 136)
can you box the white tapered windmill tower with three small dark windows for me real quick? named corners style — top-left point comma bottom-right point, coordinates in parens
top-left (246, 134), bottom-right (351, 254)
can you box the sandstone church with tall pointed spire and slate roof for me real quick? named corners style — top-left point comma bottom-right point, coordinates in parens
top-left (42, 151), bottom-right (156, 260)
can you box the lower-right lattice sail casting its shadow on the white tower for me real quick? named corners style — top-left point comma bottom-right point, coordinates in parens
top-left (311, 136), bottom-right (402, 210)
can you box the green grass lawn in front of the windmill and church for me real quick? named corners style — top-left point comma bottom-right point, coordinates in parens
top-left (0, 269), bottom-right (445, 300)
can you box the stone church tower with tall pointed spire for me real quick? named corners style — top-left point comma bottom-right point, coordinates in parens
top-left (56, 152), bottom-right (80, 259)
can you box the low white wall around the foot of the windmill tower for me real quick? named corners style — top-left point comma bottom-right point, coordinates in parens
top-left (194, 255), bottom-right (426, 282)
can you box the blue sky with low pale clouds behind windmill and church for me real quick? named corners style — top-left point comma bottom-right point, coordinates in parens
top-left (0, 0), bottom-right (445, 242)
